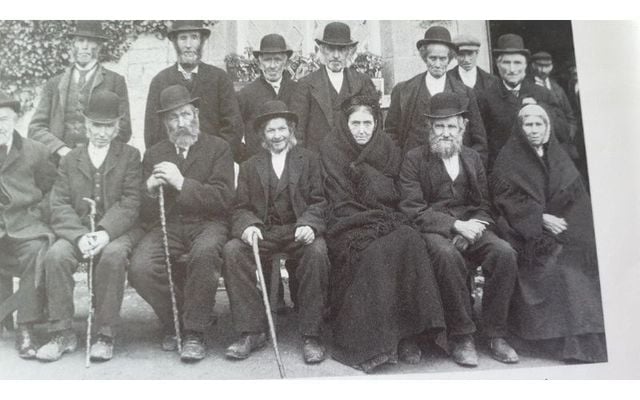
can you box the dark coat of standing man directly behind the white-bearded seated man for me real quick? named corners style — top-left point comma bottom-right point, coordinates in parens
top-left (384, 71), bottom-right (487, 163)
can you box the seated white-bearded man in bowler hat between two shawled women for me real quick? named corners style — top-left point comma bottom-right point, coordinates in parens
top-left (400, 93), bottom-right (518, 366)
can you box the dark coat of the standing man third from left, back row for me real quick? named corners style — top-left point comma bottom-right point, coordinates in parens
top-left (238, 71), bottom-right (298, 161)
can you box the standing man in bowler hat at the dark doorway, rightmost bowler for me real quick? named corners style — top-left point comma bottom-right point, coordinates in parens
top-left (478, 33), bottom-right (571, 167)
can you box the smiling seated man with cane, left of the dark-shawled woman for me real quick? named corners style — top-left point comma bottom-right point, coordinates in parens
top-left (224, 100), bottom-right (329, 364)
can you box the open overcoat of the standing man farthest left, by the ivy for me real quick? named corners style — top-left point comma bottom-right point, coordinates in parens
top-left (29, 65), bottom-right (131, 153)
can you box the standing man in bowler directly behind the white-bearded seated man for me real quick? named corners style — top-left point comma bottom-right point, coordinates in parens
top-left (385, 26), bottom-right (487, 165)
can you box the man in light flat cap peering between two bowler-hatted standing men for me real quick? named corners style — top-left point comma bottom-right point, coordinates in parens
top-left (447, 35), bottom-right (498, 97)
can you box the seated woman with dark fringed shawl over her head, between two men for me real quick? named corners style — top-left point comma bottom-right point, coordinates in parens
top-left (321, 97), bottom-right (445, 372)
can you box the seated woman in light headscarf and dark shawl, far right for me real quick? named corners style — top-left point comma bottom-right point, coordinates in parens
top-left (491, 104), bottom-right (607, 362)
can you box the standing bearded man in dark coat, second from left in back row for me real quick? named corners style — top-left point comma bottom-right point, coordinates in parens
top-left (144, 20), bottom-right (243, 160)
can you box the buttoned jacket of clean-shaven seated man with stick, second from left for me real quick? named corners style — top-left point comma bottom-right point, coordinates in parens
top-left (50, 141), bottom-right (142, 243)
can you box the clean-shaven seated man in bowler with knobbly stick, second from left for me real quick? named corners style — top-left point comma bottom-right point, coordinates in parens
top-left (36, 91), bottom-right (142, 361)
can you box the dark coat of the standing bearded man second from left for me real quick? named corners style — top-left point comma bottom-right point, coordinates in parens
top-left (144, 62), bottom-right (243, 160)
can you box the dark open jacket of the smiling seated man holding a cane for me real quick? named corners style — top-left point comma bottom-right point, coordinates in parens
top-left (231, 147), bottom-right (327, 238)
